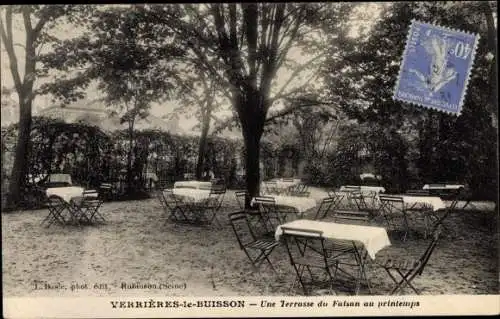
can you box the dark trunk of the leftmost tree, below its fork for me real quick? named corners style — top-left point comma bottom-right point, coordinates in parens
top-left (6, 100), bottom-right (32, 208)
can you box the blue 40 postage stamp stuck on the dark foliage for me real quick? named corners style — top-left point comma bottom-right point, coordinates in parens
top-left (394, 20), bottom-right (479, 115)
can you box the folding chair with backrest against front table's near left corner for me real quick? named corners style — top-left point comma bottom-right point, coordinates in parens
top-left (281, 226), bottom-right (338, 295)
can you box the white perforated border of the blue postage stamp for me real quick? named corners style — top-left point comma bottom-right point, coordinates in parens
top-left (392, 19), bottom-right (480, 116)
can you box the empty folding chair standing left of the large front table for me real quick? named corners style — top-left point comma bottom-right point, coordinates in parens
top-left (229, 211), bottom-right (279, 272)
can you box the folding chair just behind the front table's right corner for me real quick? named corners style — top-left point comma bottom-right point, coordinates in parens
top-left (379, 195), bottom-right (410, 241)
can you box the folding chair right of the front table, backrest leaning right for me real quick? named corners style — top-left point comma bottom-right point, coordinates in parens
top-left (375, 225), bottom-right (441, 295)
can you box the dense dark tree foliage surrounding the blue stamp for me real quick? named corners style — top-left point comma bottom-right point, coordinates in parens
top-left (324, 2), bottom-right (497, 198)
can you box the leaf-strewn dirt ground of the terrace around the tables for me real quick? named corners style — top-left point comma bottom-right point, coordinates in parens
top-left (2, 189), bottom-right (499, 297)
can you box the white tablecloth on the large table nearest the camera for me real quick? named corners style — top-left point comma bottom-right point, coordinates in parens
top-left (275, 219), bottom-right (391, 259)
